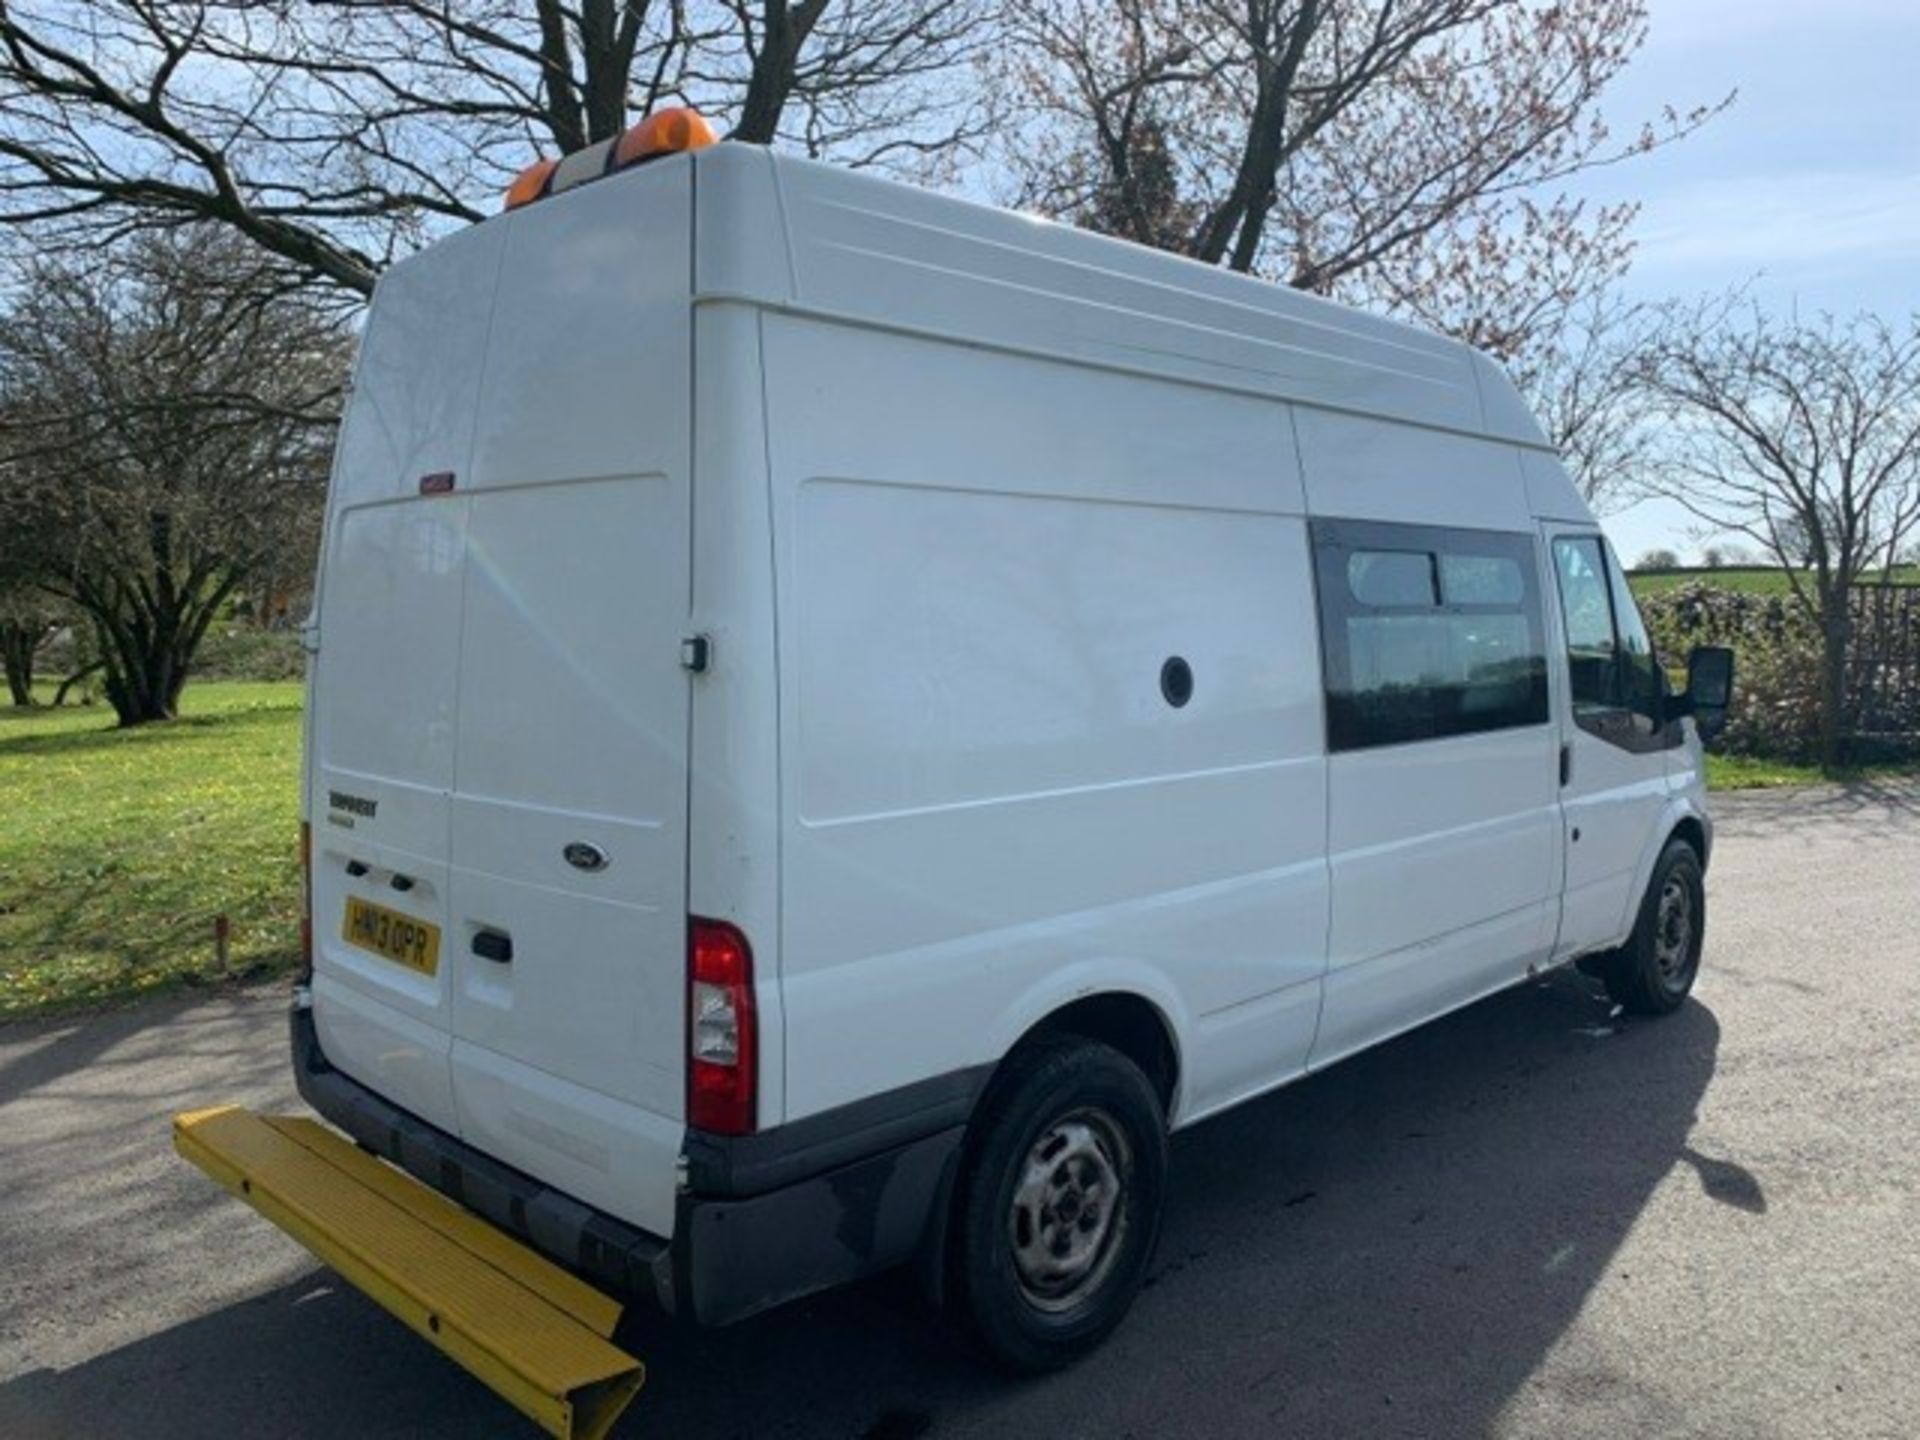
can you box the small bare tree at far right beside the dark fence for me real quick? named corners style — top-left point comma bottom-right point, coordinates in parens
top-left (1645, 307), bottom-right (1920, 768)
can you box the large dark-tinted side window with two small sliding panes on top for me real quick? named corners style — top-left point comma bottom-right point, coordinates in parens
top-left (1313, 520), bottom-right (1548, 751)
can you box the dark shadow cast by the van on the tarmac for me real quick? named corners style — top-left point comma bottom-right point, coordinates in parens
top-left (0, 973), bottom-right (1728, 1440)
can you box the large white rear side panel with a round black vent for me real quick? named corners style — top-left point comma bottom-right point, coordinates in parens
top-left (766, 317), bottom-right (1327, 1117)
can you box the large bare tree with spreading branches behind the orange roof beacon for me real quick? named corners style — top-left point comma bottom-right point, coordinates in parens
top-left (0, 0), bottom-right (981, 296)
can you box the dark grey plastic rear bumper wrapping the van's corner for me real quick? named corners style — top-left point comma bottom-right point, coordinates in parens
top-left (292, 1006), bottom-right (967, 1325)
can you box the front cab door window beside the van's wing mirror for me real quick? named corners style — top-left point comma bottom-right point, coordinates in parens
top-left (1553, 536), bottom-right (1678, 749)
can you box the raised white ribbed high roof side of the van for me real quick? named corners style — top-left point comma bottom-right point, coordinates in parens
top-left (683, 144), bottom-right (1549, 449)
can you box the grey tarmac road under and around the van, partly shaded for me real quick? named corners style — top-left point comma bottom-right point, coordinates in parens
top-left (0, 785), bottom-right (1920, 1440)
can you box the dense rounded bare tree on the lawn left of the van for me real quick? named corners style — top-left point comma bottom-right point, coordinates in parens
top-left (0, 232), bottom-right (349, 726)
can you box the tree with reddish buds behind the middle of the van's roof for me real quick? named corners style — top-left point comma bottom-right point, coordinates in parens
top-left (995, 0), bottom-right (1724, 282)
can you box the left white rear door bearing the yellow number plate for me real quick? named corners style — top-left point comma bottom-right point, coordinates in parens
top-left (307, 225), bottom-right (505, 1131)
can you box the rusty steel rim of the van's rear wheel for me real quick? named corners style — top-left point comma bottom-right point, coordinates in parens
top-left (1006, 1110), bottom-right (1133, 1313)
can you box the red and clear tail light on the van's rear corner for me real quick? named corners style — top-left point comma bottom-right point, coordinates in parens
top-left (687, 916), bottom-right (758, 1135)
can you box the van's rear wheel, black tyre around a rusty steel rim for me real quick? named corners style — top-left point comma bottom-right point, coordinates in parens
top-left (952, 1037), bottom-right (1167, 1373)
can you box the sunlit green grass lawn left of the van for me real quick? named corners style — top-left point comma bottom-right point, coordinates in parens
top-left (0, 682), bottom-right (301, 1020)
